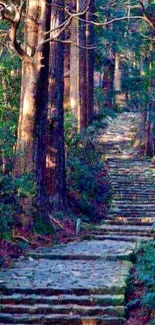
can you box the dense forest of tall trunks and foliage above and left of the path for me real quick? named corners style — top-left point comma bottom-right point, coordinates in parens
top-left (0, 0), bottom-right (155, 239)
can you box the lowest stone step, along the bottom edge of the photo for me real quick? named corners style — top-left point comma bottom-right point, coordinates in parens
top-left (0, 313), bottom-right (125, 325)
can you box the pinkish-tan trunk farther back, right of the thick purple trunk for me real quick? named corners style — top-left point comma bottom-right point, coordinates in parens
top-left (70, 0), bottom-right (88, 132)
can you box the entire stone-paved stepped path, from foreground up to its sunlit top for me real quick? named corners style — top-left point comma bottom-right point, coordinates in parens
top-left (0, 113), bottom-right (155, 325)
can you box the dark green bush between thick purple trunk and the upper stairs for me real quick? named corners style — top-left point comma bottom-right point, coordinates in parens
top-left (65, 112), bottom-right (108, 219)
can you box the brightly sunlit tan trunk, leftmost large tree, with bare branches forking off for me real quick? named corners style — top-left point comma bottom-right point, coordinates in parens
top-left (14, 0), bottom-right (38, 176)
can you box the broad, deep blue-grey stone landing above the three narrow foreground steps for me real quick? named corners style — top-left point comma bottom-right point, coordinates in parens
top-left (0, 258), bottom-right (131, 296)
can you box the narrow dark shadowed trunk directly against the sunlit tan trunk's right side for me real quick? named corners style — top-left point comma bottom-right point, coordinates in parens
top-left (34, 0), bottom-right (51, 224)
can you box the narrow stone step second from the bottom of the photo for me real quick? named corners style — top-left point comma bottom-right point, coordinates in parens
top-left (1, 304), bottom-right (126, 317)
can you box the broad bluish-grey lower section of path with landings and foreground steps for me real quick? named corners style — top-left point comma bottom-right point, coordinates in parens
top-left (0, 240), bottom-right (134, 325)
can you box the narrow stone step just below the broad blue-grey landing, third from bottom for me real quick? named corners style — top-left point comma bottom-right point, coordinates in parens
top-left (1, 294), bottom-right (125, 306)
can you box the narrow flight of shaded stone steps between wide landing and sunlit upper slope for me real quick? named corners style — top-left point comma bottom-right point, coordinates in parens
top-left (93, 159), bottom-right (155, 241)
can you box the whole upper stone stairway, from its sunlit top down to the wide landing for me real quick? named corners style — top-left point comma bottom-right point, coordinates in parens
top-left (93, 113), bottom-right (155, 241)
